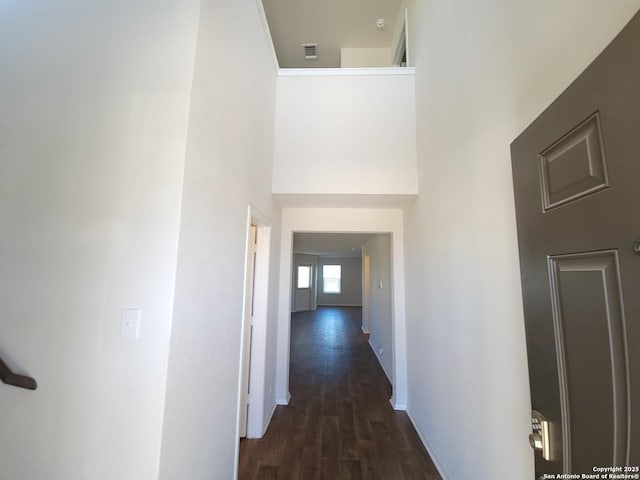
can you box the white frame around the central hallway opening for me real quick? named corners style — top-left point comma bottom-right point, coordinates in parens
top-left (276, 208), bottom-right (407, 410)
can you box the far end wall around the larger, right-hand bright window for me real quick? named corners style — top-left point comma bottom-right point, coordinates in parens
top-left (318, 256), bottom-right (362, 307)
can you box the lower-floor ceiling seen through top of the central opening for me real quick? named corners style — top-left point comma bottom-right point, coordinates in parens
top-left (293, 233), bottom-right (375, 257)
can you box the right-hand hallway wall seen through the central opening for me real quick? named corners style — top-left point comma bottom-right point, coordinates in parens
top-left (362, 234), bottom-right (393, 382)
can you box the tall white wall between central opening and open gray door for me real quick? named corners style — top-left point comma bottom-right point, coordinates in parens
top-left (405, 0), bottom-right (640, 480)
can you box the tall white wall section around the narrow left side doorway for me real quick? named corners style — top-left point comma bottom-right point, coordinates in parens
top-left (160, 0), bottom-right (280, 480)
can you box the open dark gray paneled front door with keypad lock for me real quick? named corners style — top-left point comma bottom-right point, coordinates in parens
top-left (511, 10), bottom-right (640, 478)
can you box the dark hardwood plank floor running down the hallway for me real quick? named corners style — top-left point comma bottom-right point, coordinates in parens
top-left (239, 307), bottom-right (441, 480)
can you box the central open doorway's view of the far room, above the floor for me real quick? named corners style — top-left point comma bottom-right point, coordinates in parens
top-left (278, 227), bottom-right (395, 400)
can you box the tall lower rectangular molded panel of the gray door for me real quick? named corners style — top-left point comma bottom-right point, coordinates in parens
top-left (548, 250), bottom-right (630, 472)
